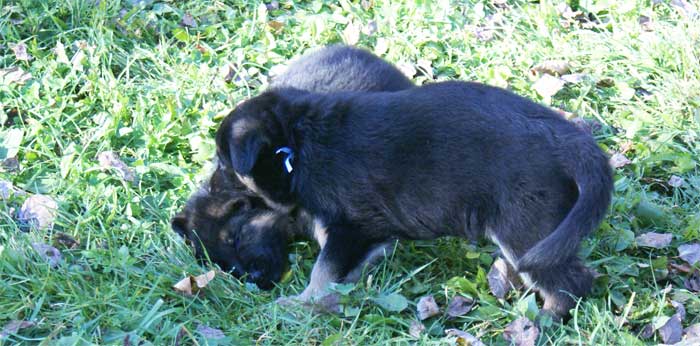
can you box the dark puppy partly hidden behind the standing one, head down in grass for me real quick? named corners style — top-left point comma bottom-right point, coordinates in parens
top-left (171, 45), bottom-right (413, 289)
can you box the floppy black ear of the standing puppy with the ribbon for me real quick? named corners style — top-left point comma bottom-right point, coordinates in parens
top-left (216, 115), bottom-right (269, 175)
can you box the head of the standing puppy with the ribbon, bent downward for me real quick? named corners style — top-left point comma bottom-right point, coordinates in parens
top-left (216, 89), bottom-right (301, 209)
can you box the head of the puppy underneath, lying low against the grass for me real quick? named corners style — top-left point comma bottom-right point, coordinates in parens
top-left (171, 171), bottom-right (291, 289)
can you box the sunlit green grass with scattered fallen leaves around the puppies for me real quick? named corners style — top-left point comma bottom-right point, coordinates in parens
top-left (0, 0), bottom-right (700, 345)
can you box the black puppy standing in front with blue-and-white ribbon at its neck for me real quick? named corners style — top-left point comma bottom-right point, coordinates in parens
top-left (217, 82), bottom-right (612, 316)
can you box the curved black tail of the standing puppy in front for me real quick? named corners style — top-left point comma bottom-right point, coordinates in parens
top-left (517, 133), bottom-right (613, 272)
